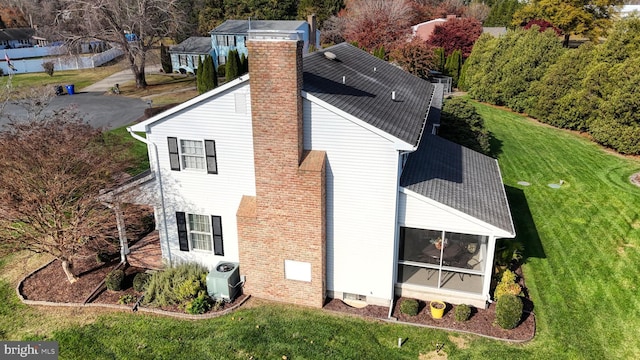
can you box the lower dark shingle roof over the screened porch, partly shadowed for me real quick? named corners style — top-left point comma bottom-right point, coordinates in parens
top-left (400, 134), bottom-right (515, 234)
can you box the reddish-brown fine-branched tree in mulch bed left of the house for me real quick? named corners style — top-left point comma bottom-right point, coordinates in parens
top-left (0, 88), bottom-right (127, 283)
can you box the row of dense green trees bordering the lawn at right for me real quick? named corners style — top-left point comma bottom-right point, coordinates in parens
top-left (460, 17), bottom-right (640, 155)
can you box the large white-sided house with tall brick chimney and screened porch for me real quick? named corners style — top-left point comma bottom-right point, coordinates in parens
top-left (128, 31), bottom-right (515, 308)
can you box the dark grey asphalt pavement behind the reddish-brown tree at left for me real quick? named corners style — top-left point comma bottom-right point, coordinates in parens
top-left (0, 92), bottom-right (147, 129)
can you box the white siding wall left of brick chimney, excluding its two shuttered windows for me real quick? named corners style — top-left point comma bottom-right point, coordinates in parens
top-left (147, 83), bottom-right (255, 267)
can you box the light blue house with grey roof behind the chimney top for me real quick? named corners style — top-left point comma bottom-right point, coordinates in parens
top-left (211, 15), bottom-right (320, 66)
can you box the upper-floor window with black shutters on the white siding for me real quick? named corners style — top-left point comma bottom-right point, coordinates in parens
top-left (167, 137), bottom-right (218, 174)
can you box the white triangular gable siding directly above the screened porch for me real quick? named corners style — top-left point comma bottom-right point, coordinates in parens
top-left (398, 193), bottom-right (494, 235)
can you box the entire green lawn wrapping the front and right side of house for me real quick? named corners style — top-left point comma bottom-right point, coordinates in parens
top-left (0, 105), bottom-right (640, 359)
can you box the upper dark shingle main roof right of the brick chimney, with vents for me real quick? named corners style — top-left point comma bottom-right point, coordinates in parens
top-left (303, 43), bottom-right (433, 145)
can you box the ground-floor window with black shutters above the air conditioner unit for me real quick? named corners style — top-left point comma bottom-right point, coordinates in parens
top-left (176, 212), bottom-right (224, 255)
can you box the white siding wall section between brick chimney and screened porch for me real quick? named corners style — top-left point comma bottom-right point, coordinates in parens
top-left (304, 100), bottom-right (398, 299)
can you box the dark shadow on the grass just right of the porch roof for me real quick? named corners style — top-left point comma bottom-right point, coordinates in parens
top-left (505, 185), bottom-right (547, 263)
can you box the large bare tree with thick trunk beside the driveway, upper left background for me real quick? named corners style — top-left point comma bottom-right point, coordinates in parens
top-left (59, 0), bottom-right (184, 88)
